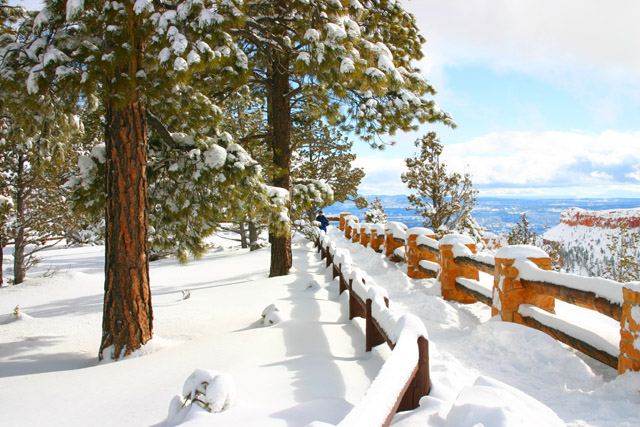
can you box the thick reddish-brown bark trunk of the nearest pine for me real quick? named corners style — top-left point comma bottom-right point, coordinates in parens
top-left (99, 102), bottom-right (153, 360)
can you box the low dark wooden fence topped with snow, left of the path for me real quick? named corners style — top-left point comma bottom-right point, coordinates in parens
top-left (315, 232), bottom-right (431, 426)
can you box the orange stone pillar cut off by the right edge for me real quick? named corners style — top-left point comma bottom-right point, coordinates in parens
top-left (618, 282), bottom-right (640, 374)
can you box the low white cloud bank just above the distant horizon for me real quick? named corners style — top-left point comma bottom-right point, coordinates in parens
top-left (354, 131), bottom-right (640, 196)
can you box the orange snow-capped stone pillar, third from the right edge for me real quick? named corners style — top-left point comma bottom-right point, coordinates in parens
top-left (438, 234), bottom-right (480, 304)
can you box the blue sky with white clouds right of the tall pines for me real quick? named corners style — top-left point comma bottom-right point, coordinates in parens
top-left (357, 0), bottom-right (640, 197)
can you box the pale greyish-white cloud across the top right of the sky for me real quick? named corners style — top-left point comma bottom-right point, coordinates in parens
top-left (404, 0), bottom-right (640, 75)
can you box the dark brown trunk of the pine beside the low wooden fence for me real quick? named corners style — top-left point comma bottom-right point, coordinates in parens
top-left (268, 54), bottom-right (293, 277)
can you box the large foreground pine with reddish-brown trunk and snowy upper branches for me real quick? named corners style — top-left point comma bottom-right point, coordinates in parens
top-left (28, 0), bottom-right (255, 359)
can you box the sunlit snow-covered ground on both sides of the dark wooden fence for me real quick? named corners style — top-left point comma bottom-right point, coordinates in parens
top-left (0, 227), bottom-right (640, 427)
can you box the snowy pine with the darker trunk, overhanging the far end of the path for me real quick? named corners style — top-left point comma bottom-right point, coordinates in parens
top-left (234, 0), bottom-right (453, 276)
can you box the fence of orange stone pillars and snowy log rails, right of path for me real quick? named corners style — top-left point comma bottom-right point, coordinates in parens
top-left (342, 214), bottom-right (640, 373)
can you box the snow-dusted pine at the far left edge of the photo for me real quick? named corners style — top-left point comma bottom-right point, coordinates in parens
top-left (0, 2), bottom-right (80, 284)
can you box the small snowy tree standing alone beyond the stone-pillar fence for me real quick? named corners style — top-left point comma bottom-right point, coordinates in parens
top-left (402, 132), bottom-right (478, 237)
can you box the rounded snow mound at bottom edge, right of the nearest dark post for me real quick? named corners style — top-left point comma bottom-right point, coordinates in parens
top-left (444, 376), bottom-right (565, 427)
